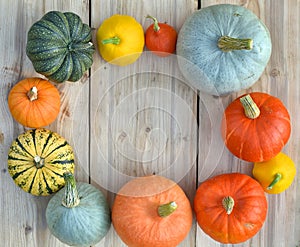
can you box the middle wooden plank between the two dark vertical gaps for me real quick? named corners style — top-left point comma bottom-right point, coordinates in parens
top-left (90, 0), bottom-right (197, 246)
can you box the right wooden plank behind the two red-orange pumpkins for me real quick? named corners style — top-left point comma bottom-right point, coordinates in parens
top-left (197, 0), bottom-right (300, 247)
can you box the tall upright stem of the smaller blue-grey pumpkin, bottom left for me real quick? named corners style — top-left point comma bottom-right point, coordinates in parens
top-left (62, 172), bottom-right (80, 208)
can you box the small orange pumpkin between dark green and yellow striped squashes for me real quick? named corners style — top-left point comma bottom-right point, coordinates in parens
top-left (8, 78), bottom-right (60, 128)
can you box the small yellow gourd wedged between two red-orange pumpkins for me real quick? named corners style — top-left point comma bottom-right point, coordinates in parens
top-left (252, 152), bottom-right (296, 194)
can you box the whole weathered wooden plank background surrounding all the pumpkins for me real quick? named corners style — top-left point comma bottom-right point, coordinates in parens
top-left (0, 0), bottom-right (300, 247)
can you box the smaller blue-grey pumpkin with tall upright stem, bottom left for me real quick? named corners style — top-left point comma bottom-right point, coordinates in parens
top-left (46, 172), bottom-right (111, 246)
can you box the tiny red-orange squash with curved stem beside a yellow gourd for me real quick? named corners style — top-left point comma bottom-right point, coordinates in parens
top-left (145, 15), bottom-right (177, 57)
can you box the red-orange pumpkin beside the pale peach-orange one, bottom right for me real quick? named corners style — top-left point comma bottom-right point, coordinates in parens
top-left (194, 173), bottom-right (268, 244)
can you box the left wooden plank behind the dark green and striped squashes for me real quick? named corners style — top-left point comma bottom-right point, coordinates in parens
top-left (0, 0), bottom-right (89, 247)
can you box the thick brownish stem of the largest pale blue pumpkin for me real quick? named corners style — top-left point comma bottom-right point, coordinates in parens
top-left (218, 36), bottom-right (253, 52)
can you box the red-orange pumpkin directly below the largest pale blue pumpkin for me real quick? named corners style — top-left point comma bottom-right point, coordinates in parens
top-left (221, 92), bottom-right (291, 162)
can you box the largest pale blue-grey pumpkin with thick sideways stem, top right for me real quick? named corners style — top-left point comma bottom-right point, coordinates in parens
top-left (176, 4), bottom-right (272, 96)
